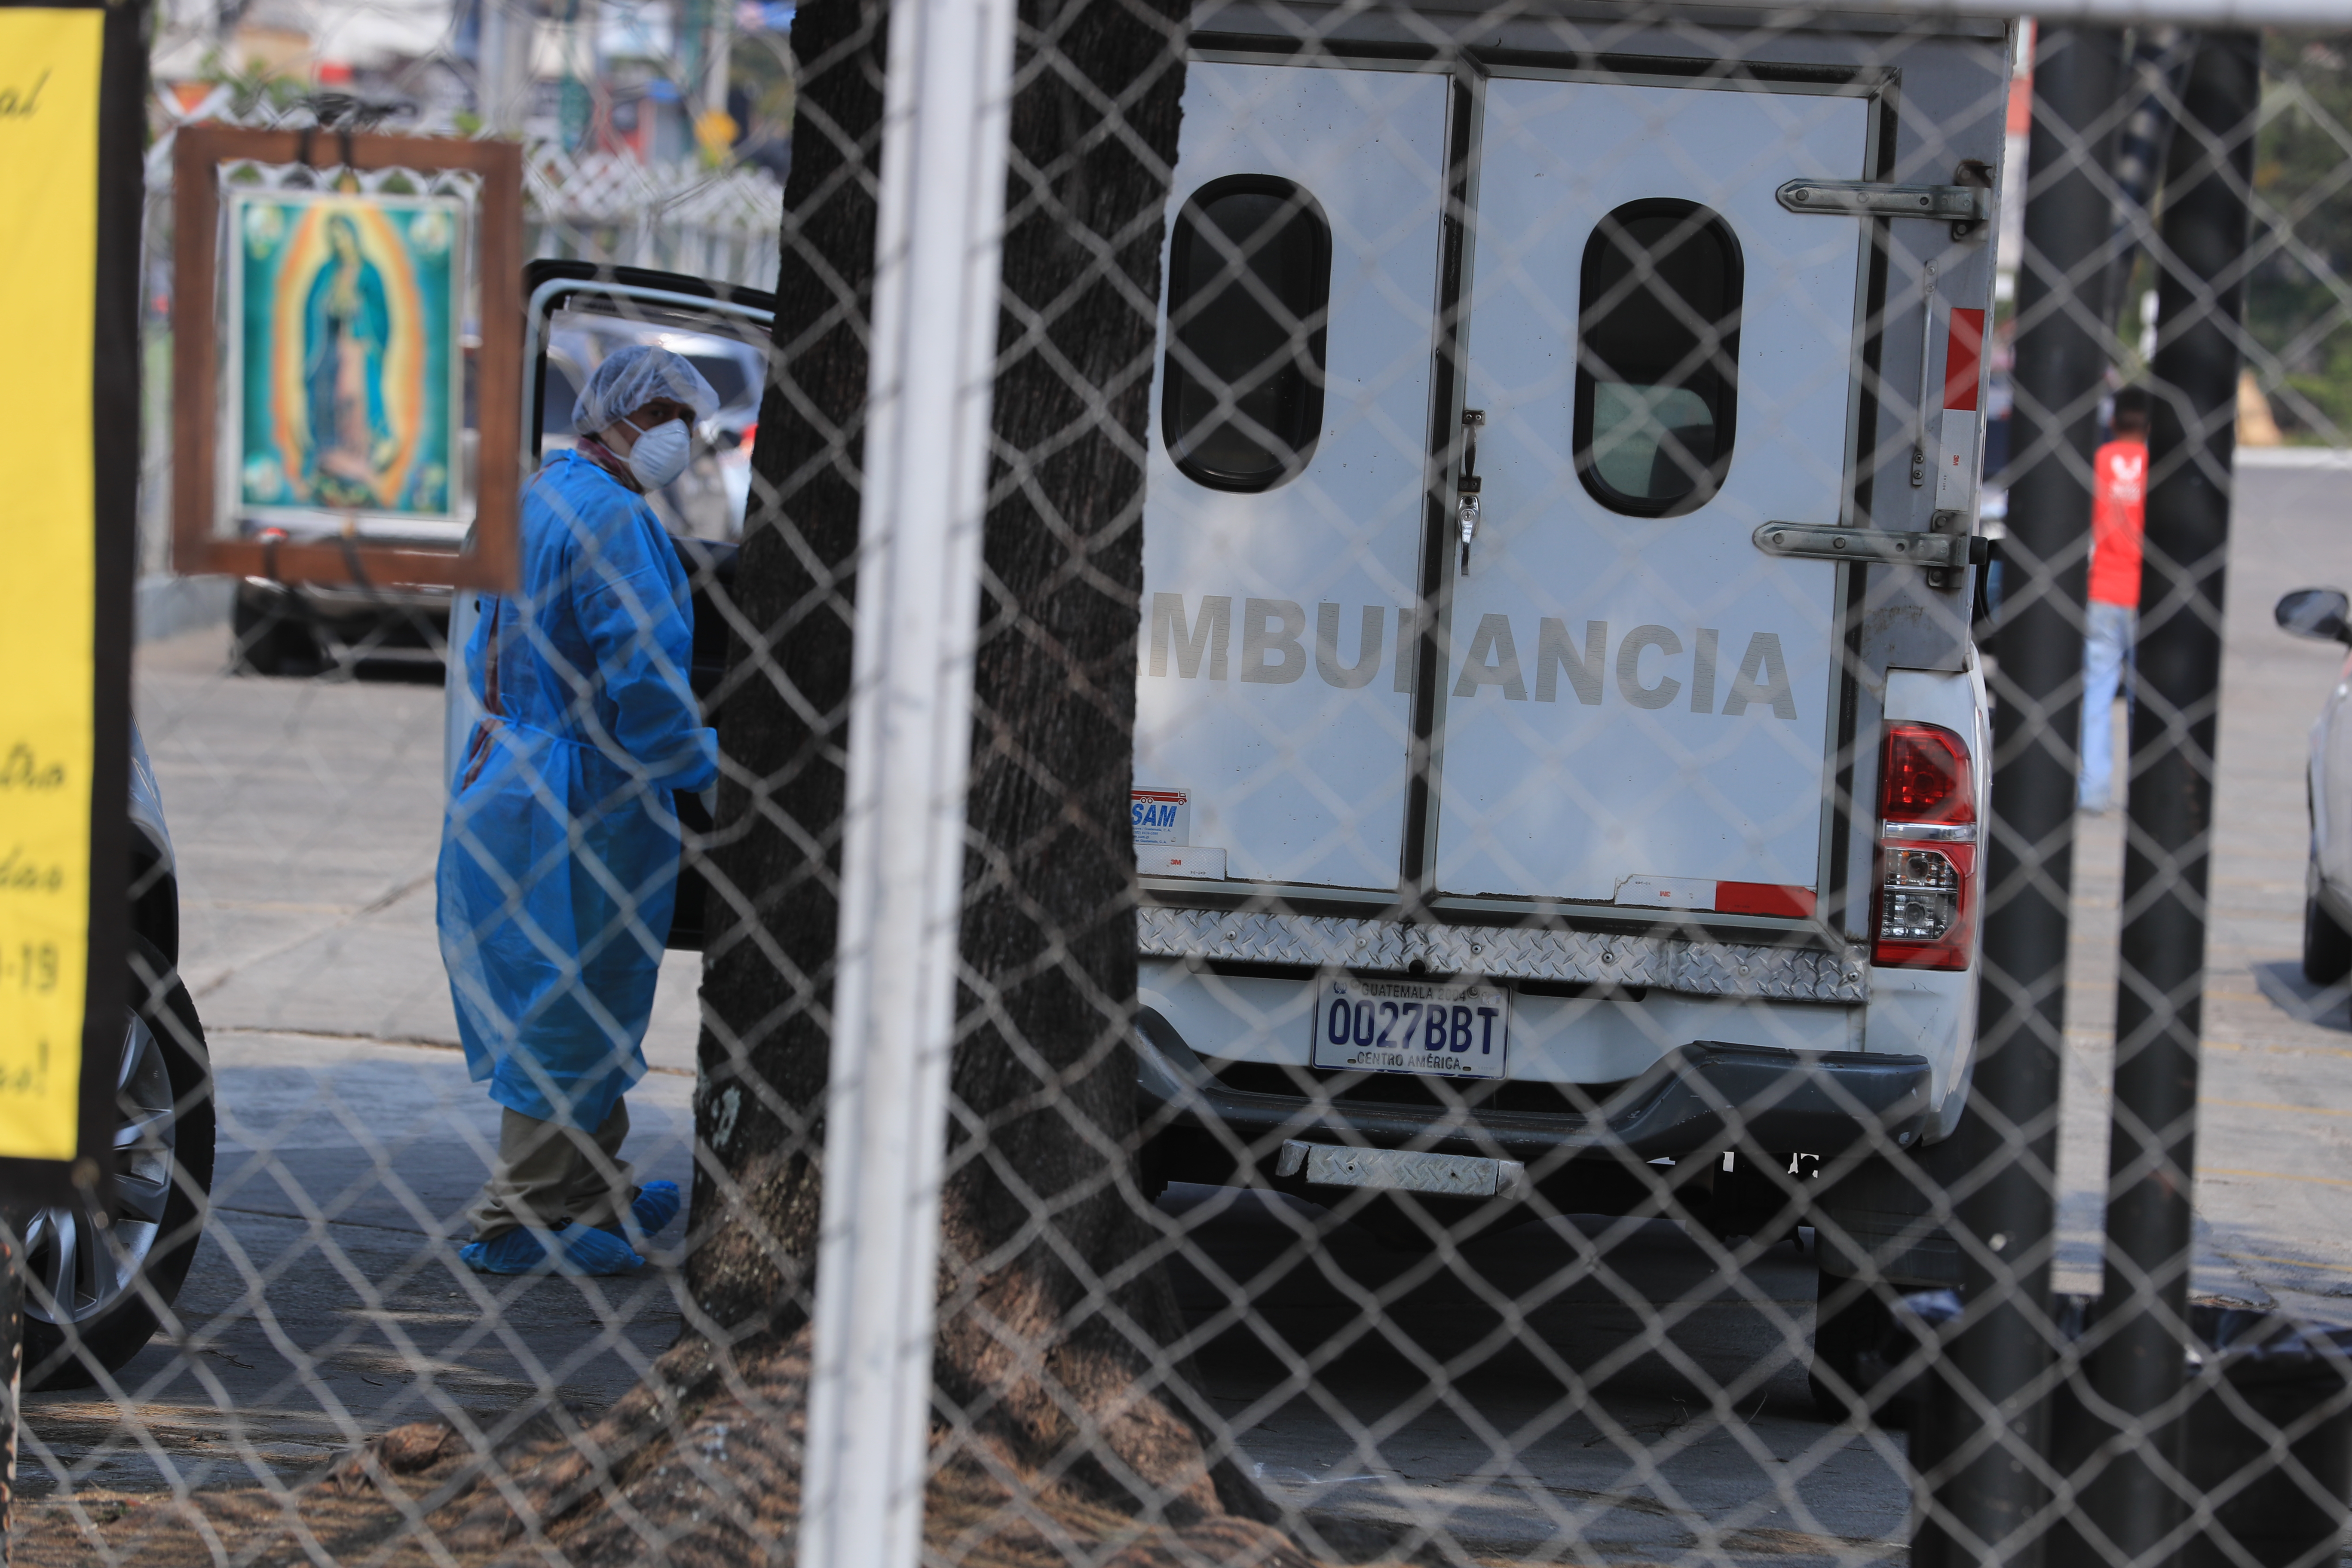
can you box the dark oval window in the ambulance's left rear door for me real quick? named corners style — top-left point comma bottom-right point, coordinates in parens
top-left (1160, 174), bottom-right (1331, 491)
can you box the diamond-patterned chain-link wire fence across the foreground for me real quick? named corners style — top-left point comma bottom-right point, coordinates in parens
top-left (23, 0), bottom-right (2352, 1568)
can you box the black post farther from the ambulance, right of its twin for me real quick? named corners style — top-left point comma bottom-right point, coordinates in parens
top-left (2089, 33), bottom-right (2263, 1561)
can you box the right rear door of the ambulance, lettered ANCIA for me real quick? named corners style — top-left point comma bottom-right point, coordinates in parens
top-left (1430, 70), bottom-right (1872, 917)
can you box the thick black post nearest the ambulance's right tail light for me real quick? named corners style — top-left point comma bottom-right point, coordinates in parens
top-left (1914, 28), bottom-right (2122, 1566)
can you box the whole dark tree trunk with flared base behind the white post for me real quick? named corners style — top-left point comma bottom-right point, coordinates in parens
top-left (423, 0), bottom-right (1301, 1563)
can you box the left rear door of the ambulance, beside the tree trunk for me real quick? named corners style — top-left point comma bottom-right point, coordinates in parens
top-left (1134, 52), bottom-right (1449, 903)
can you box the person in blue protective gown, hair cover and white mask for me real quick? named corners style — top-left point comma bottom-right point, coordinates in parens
top-left (438, 346), bottom-right (717, 1274)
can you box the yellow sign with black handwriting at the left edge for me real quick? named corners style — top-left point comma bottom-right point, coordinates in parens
top-left (0, 7), bottom-right (103, 1159)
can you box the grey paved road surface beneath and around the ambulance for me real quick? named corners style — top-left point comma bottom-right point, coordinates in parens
top-left (28, 451), bottom-right (2352, 1561)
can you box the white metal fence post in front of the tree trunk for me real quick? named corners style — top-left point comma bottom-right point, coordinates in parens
top-left (799, 0), bottom-right (1014, 1568)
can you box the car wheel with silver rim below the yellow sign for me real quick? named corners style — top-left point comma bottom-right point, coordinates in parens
top-left (24, 936), bottom-right (214, 1389)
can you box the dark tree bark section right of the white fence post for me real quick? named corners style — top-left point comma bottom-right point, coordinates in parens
top-left (936, 0), bottom-right (1263, 1523)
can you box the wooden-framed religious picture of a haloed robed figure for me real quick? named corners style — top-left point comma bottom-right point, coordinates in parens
top-left (172, 127), bottom-right (522, 588)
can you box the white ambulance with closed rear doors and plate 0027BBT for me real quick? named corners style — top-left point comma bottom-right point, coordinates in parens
top-left (1134, 5), bottom-right (2011, 1326)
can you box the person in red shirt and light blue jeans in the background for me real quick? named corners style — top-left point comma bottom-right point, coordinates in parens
top-left (2077, 386), bottom-right (2147, 811)
